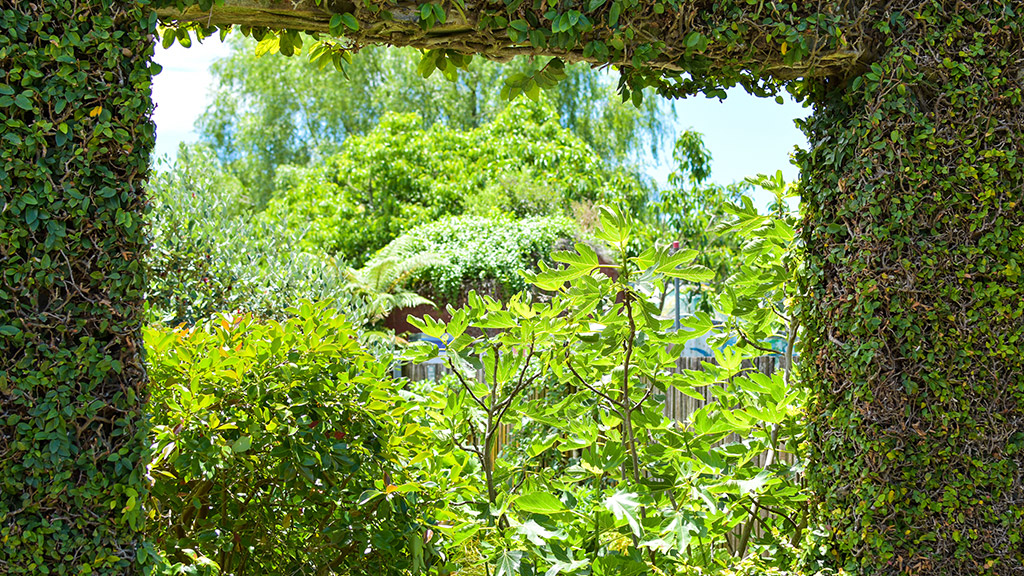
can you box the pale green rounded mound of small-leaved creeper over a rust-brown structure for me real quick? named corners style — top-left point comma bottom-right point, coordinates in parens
top-left (369, 215), bottom-right (578, 304)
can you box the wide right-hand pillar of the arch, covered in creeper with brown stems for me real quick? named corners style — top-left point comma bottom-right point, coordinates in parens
top-left (801, 1), bottom-right (1024, 576)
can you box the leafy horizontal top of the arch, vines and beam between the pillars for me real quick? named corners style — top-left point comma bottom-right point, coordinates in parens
top-left (160, 0), bottom-right (868, 102)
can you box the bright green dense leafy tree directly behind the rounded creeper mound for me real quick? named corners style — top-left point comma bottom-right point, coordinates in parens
top-left (266, 102), bottom-right (646, 264)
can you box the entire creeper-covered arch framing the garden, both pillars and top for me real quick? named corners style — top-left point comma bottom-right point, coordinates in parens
top-left (0, 0), bottom-right (1024, 575)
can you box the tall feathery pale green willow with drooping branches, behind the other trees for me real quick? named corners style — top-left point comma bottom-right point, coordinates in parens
top-left (199, 37), bottom-right (668, 202)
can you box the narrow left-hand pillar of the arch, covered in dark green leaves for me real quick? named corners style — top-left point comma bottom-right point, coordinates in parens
top-left (0, 0), bottom-right (156, 575)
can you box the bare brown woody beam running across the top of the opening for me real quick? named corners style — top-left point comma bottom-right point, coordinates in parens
top-left (157, 0), bottom-right (869, 85)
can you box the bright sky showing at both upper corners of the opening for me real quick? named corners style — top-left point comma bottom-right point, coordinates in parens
top-left (153, 38), bottom-right (810, 196)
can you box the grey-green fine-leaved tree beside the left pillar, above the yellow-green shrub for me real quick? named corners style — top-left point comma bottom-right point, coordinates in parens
top-left (146, 148), bottom-right (361, 325)
